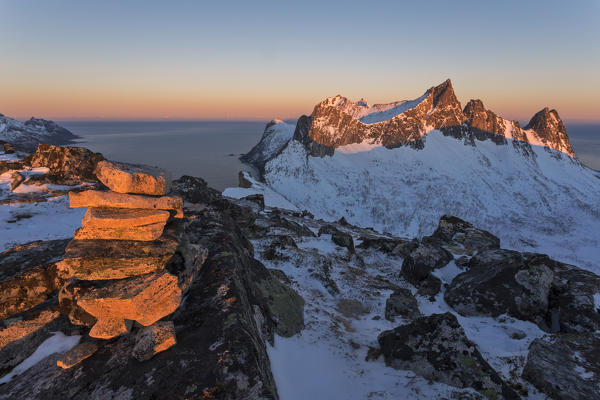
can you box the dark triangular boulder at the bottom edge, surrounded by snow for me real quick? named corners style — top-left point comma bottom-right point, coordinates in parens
top-left (378, 313), bottom-right (519, 399)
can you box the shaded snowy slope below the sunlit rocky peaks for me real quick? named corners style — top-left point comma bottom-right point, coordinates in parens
top-left (265, 130), bottom-right (600, 273)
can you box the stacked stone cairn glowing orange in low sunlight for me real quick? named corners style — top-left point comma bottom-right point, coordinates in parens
top-left (57, 161), bottom-right (207, 368)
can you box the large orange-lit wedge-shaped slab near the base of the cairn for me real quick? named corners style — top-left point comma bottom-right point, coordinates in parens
top-left (77, 271), bottom-right (181, 339)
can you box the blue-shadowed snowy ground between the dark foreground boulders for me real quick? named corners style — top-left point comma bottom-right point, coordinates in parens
top-left (253, 220), bottom-right (545, 400)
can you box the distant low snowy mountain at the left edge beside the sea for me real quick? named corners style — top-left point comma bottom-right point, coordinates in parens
top-left (0, 114), bottom-right (77, 151)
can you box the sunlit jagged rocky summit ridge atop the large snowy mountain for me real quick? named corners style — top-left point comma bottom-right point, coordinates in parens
top-left (286, 79), bottom-right (575, 157)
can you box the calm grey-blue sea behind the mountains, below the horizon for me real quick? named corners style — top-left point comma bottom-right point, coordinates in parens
top-left (60, 121), bottom-right (600, 190)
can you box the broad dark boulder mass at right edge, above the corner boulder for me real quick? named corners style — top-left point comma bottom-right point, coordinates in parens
top-left (444, 249), bottom-right (600, 332)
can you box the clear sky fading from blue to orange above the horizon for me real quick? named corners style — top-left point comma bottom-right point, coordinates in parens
top-left (0, 0), bottom-right (600, 122)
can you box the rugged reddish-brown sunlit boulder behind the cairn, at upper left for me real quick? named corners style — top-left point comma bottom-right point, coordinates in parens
top-left (22, 143), bottom-right (104, 185)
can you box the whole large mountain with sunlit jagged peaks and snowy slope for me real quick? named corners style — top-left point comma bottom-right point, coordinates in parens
top-left (241, 80), bottom-right (600, 270)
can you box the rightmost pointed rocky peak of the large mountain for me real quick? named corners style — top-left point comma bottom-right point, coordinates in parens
top-left (525, 107), bottom-right (575, 157)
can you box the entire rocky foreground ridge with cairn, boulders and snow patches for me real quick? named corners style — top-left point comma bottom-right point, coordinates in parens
top-left (0, 145), bottom-right (600, 399)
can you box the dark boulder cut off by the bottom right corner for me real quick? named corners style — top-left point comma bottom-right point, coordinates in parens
top-left (523, 334), bottom-right (600, 400)
